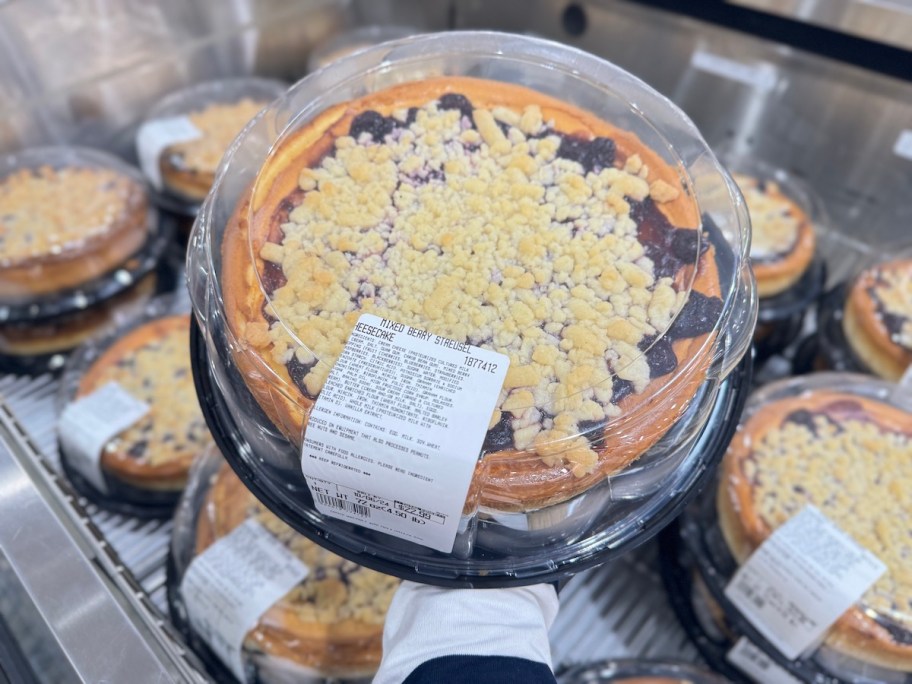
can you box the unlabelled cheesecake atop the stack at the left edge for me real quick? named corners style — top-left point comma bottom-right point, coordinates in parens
top-left (0, 165), bottom-right (148, 301)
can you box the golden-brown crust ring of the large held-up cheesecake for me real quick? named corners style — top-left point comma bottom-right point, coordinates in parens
top-left (222, 78), bottom-right (720, 510)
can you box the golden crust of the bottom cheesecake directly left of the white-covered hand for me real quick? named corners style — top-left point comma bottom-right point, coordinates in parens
top-left (195, 463), bottom-right (398, 677)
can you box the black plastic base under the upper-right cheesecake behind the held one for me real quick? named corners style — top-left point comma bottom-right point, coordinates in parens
top-left (754, 257), bottom-right (826, 363)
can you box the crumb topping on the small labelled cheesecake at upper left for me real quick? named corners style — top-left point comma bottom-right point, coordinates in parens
top-left (164, 98), bottom-right (267, 173)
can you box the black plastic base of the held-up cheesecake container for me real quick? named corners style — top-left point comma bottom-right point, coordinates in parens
top-left (190, 319), bottom-right (753, 588)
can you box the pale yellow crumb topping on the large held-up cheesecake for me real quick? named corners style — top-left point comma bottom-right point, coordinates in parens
top-left (256, 102), bottom-right (686, 477)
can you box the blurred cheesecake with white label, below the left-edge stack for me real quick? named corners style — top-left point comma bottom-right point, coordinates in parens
top-left (76, 315), bottom-right (211, 493)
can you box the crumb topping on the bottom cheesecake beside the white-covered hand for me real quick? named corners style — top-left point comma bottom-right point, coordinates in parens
top-left (250, 502), bottom-right (399, 625)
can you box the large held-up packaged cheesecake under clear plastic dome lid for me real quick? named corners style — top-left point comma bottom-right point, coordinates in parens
top-left (189, 33), bottom-right (756, 581)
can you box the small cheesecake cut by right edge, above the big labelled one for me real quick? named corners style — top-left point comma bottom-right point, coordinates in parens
top-left (843, 259), bottom-right (912, 380)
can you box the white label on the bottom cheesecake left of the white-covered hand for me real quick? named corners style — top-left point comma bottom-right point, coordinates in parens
top-left (181, 518), bottom-right (309, 682)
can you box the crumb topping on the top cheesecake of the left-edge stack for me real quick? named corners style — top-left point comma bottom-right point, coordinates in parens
top-left (0, 166), bottom-right (143, 267)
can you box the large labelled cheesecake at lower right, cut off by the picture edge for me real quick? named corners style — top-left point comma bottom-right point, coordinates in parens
top-left (718, 390), bottom-right (912, 672)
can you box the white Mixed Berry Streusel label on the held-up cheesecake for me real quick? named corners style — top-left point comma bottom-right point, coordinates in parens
top-left (301, 314), bottom-right (510, 553)
